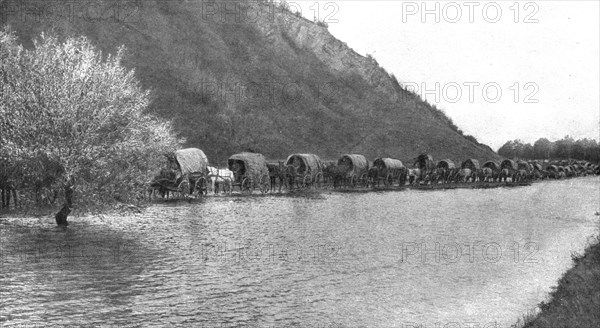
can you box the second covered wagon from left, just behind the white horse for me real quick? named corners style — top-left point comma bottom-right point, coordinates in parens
top-left (227, 152), bottom-right (271, 193)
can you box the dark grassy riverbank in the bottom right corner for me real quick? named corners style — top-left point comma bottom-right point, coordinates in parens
top-left (512, 217), bottom-right (600, 328)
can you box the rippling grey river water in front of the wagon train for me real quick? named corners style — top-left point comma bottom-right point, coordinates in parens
top-left (0, 178), bottom-right (599, 327)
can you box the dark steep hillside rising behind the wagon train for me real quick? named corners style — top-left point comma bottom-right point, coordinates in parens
top-left (1, 0), bottom-right (498, 162)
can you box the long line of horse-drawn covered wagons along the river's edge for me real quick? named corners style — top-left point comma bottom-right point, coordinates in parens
top-left (150, 148), bottom-right (600, 198)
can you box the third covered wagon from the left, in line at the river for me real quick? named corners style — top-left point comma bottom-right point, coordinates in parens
top-left (285, 154), bottom-right (325, 187)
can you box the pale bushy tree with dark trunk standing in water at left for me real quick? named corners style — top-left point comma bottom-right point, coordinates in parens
top-left (0, 30), bottom-right (180, 225)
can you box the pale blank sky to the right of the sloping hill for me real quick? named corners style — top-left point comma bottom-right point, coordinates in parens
top-left (288, 0), bottom-right (600, 149)
